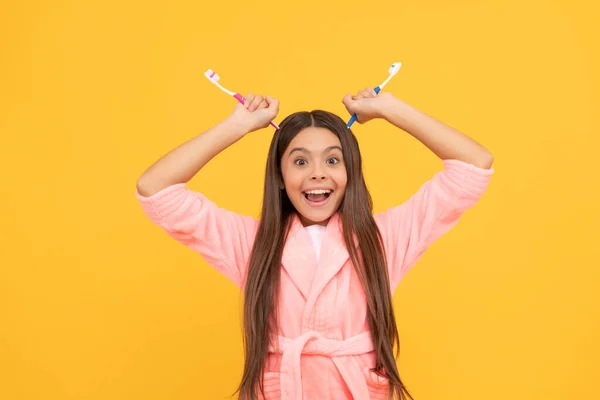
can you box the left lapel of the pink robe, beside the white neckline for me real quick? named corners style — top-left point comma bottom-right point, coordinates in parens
top-left (281, 215), bottom-right (317, 300)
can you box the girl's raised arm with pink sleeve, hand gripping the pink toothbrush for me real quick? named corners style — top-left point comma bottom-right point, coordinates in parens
top-left (136, 95), bottom-right (278, 287)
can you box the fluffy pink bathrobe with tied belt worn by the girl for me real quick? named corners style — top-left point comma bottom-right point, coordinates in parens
top-left (136, 160), bottom-right (494, 400)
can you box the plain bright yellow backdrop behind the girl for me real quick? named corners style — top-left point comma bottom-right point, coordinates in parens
top-left (0, 0), bottom-right (600, 400)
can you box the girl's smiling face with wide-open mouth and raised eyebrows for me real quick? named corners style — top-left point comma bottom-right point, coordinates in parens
top-left (281, 127), bottom-right (348, 226)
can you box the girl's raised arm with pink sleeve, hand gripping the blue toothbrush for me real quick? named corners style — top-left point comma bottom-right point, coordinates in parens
top-left (343, 89), bottom-right (494, 290)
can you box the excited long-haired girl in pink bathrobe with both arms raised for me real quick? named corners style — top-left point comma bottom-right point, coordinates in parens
top-left (136, 89), bottom-right (493, 400)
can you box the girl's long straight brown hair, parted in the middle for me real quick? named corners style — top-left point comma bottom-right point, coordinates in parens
top-left (237, 110), bottom-right (412, 400)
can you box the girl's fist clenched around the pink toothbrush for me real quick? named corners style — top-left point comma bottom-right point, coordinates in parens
top-left (228, 93), bottom-right (279, 133)
